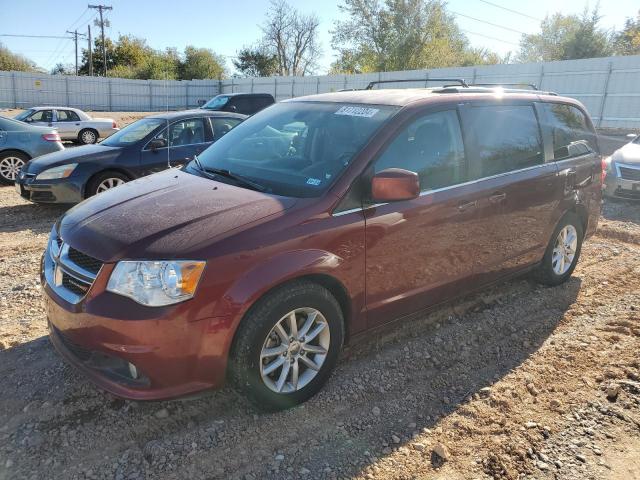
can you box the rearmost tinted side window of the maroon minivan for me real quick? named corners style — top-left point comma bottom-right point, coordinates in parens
top-left (544, 103), bottom-right (596, 160)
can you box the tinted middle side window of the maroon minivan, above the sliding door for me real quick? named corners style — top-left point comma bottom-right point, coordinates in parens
top-left (465, 105), bottom-right (544, 179)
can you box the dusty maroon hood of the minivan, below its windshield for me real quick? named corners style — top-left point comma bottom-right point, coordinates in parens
top-left (59, 169), bottom-right (296, 262)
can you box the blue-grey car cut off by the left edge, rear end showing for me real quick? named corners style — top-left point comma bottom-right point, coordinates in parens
top-left (0, 116), bottom-right (64, 184)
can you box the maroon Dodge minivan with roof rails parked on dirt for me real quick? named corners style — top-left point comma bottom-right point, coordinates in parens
top-left (42, 85), bottom-right (602, 408)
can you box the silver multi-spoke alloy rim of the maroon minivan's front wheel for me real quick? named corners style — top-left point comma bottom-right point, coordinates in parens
top-left (260, 307), bottom-right (331, 393)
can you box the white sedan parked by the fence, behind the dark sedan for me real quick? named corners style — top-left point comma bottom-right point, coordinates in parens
top-left (14, 106), bottom-right (120, 145)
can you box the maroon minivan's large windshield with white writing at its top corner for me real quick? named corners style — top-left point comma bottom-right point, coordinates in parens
top-left (190, 102), bottom-right (398, 197)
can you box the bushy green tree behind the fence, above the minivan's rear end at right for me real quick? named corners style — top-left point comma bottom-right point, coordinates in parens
top-left (517, 6), bottom-right (614, 62)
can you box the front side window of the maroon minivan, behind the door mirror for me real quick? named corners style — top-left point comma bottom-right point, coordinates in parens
top-left (375, 110), bottom-right (465, 191)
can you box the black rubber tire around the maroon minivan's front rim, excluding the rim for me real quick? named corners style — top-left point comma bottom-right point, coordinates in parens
top-left (228, 281), bottom-right (344, 411)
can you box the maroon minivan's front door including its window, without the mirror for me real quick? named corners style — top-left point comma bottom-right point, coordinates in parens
top-left (365, 109), bottom-right (483, 326)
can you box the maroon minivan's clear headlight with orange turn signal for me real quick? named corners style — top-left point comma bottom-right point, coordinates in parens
top-left (107, 260), bottom-right (205, 307)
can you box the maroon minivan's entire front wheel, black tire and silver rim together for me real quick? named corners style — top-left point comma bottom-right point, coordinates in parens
top-left (229, 281), bottom-right (344, 410)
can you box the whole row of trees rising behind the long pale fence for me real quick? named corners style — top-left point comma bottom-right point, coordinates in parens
top-left (0, 0), bottom-right (640, 80)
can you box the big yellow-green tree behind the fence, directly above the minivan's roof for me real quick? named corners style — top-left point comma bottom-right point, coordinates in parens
top-left (331, 0), bottom-right (500, 73)
